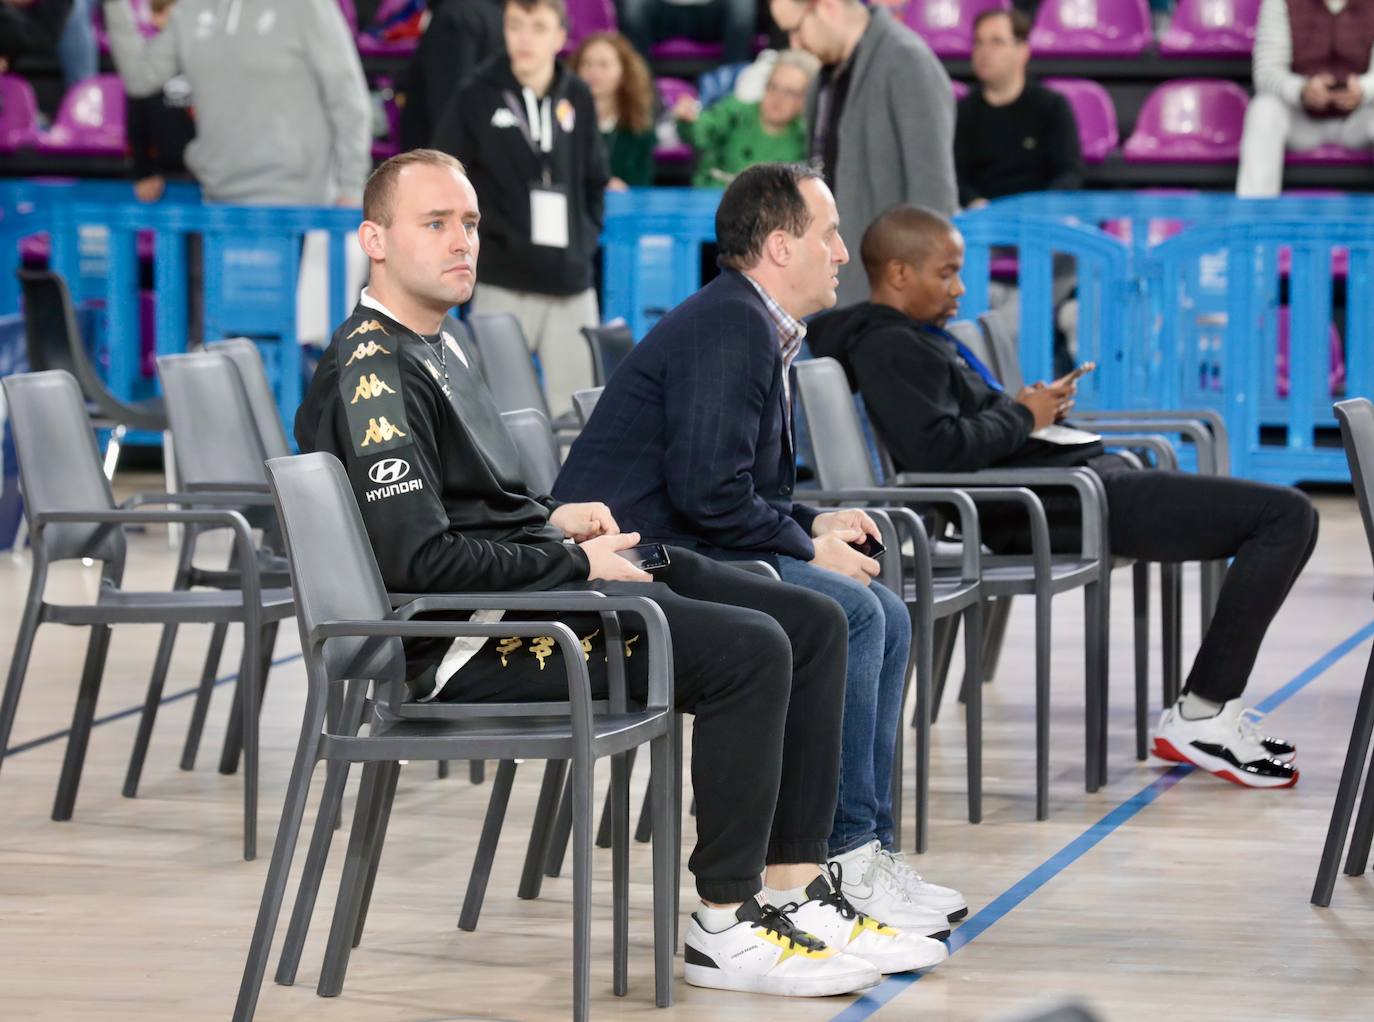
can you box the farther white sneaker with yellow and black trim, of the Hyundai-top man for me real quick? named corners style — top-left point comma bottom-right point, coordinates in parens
top-left (780, 863), bottom-right (949, 975)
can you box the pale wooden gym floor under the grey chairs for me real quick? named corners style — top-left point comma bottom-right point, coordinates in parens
top-left (0, 478), bottom-right (1374, 1022)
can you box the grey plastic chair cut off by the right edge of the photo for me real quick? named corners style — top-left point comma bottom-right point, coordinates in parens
top-left (1312, 397), bottom-right (1374, 907)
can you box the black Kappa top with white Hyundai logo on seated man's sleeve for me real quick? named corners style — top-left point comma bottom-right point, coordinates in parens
top-left (295, 305), bottom-right (588, 676)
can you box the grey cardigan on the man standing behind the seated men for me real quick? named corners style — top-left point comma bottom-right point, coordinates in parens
top-left (807, 7), bottom-right (959, 305)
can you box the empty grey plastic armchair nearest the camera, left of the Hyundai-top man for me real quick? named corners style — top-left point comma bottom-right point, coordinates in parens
top-left (234, 453), bottom-right (677, 1022)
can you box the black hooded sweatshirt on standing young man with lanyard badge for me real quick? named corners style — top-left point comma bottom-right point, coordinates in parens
top-left (434, 55), bottom-right (607, 295)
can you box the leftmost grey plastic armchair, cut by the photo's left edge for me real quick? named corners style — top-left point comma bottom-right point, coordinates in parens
top-left (0, 371), bottom-right (293, 859)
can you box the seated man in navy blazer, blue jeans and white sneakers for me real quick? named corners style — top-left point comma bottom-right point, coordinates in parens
top-left (554, 163), bottom-right (967, 937)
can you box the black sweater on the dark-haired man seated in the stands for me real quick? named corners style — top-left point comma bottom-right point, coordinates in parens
top-left (954, 81), bottom-right (1083, 206)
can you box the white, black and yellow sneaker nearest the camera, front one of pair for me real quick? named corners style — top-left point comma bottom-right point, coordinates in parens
top-left (683, 898), bottom-right (882, 997)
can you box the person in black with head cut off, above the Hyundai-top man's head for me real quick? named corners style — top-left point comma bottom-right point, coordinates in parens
top-left (401, 0), bottom-right (506, 148)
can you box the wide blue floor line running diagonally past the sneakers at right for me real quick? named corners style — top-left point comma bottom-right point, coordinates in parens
top-left (831, 621), bottom-right (1374, 1022)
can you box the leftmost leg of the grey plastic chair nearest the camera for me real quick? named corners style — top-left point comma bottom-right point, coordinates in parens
top-left (234, 701), bottom-right (324, 1022)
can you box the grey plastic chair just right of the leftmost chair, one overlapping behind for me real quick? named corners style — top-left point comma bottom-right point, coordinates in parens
top-left (149, 354), bottom-right (290, 798)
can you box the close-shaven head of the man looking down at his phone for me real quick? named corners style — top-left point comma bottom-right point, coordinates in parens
top-left (860, 206), bottom-right (963, 324)
